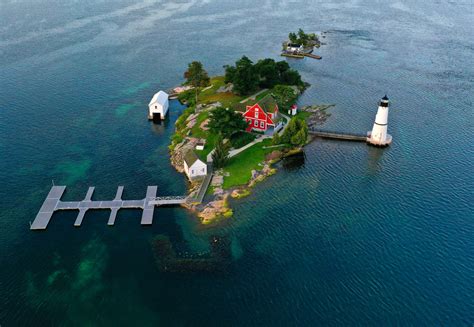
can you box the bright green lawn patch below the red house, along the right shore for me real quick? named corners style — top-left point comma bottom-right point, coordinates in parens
top-left (223, 139), bottom-right (274, 189)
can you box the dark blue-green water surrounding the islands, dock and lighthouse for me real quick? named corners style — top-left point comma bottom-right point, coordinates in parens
top-left (0, 0), bottom-right (474, 326)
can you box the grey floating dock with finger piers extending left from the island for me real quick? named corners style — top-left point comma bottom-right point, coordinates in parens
top-left (30, 186), bottom-right (187, 230)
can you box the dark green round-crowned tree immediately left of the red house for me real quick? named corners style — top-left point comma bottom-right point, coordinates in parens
top-left (207, 107), bottom-right (248, 138)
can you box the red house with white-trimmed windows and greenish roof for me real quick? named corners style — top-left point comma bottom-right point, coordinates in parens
top-left (243, 95), bottom-right (280, 132)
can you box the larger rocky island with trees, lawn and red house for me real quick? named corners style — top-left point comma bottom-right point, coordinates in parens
top-left (169, 56), bottom-right (328, 224)
